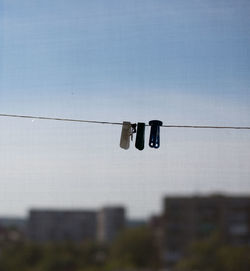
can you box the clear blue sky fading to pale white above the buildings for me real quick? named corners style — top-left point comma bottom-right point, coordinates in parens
top-left (0, 0), bottom-right (250, 218)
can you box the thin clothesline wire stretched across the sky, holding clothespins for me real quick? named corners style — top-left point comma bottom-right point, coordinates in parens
top-left (0, 114), bottom-right (250, 130)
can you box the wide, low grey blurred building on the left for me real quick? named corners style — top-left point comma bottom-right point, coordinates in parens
top-left (28, 210), bottom-right (97, 242)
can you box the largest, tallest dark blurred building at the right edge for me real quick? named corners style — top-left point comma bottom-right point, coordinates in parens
top-left (151, 195), bottom-right (250, 267)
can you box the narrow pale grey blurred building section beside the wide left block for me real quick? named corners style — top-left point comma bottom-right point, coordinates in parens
top-left (97, 207), bottom-right (126, 242)
